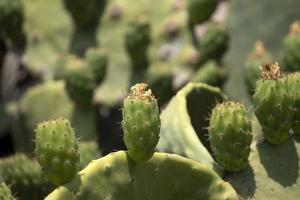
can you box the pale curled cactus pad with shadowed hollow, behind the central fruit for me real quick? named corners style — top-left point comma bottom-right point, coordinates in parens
top-left (157, 83), bottom-right (224, 172)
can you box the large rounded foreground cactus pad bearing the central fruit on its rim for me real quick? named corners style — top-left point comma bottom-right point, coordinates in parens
top-left (46, 151), bottom-right (238, 200)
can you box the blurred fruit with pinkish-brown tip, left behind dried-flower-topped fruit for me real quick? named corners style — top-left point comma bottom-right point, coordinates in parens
top-left (245, 41), bottom-right (271, 95)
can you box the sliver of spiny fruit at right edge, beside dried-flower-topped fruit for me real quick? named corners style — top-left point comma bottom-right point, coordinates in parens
top-left (288, 72), bottom-right (300, 135)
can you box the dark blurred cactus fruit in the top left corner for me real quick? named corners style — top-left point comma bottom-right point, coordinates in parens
top-left (0, 0), bottom-right (25, 47)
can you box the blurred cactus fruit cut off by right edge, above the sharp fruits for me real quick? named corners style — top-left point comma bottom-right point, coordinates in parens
top-left (281, 20), bottom-right (300, 72)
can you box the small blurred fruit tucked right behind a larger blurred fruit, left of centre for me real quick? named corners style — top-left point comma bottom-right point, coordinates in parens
top-left (85, 48), bottom-right (108, 84)
